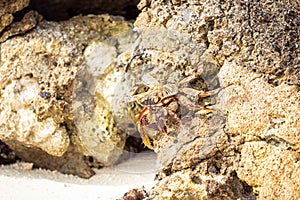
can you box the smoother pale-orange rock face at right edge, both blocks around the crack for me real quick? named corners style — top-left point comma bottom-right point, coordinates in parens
top-left (219, 62), bottom-right (300, 199)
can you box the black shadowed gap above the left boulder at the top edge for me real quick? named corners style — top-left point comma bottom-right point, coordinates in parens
top-left (15, 0), bottom-right (140, 21)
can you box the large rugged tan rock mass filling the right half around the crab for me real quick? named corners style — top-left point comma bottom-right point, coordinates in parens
top-left (128, 0), bottom-right (300, 199)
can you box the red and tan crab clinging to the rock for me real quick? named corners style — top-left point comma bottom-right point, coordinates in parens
top-left (125, 65), bottom-right (234, 149)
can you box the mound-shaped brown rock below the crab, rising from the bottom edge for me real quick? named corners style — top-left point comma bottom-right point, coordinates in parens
top-left (149, 133), bottom-right (255, 199)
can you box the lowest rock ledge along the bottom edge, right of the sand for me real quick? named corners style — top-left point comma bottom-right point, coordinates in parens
top-left (149, 167), bottom-right (256, 200)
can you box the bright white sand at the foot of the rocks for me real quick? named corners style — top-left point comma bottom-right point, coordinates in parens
top-left (0, 153), bottom-right (157, 200)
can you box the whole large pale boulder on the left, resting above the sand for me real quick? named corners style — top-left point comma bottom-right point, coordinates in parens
top-left (0, 15), bottom-right (136, 177)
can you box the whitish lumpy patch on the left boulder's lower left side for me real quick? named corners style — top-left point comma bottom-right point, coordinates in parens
top-left (1, 75), bottom-right (70, 156)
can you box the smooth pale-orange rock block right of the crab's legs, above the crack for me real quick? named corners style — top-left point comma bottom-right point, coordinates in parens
top-left (219, 62), bottom-right (300, 152)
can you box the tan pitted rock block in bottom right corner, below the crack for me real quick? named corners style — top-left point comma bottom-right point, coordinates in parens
top-left (237, 141), bottom-right (300, 199)
